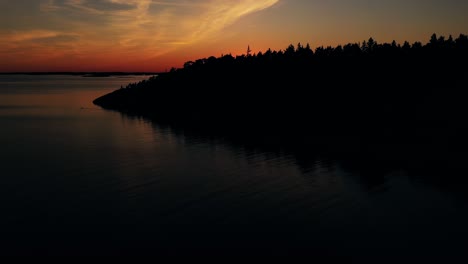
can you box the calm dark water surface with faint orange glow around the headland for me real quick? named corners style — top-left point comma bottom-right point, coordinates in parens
top-left (0, 75), bottom-right (468, 256)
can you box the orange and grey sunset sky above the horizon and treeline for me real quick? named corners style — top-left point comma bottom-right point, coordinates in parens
top-left (0, 0), bottom-right (468, 72)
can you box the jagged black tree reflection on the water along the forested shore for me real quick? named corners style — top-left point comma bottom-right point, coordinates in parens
top-left (121, 113), bottom-right (416, 195)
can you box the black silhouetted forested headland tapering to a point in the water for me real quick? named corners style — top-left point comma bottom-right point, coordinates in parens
top-left (94, 34), bottom-right (468, 169)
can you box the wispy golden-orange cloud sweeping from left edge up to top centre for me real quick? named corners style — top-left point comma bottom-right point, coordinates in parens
top-left (0, 0), bottom-right (279, 70)
